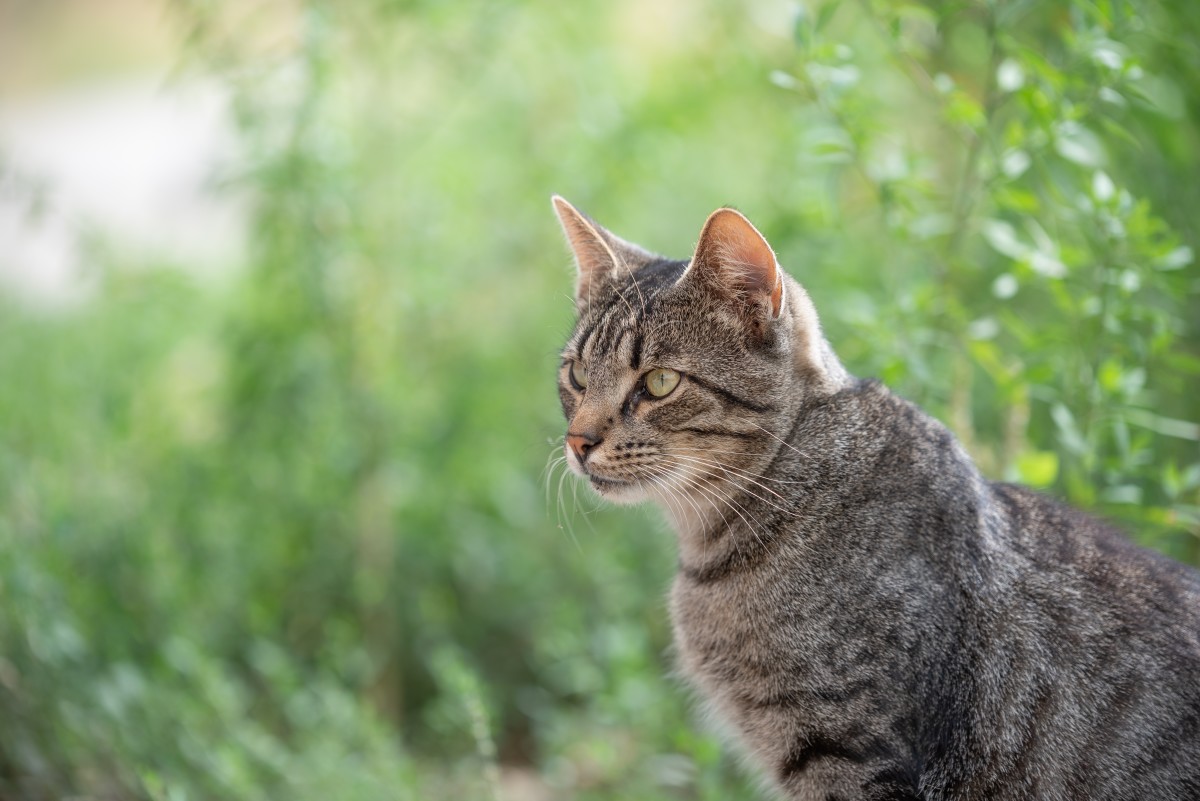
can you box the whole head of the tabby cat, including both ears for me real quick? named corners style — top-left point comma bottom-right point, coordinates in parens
top-left (553, 197), bottom-right (848, 505)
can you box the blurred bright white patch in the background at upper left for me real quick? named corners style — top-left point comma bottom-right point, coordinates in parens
top-left (0, 78), bottom-right (246, 307)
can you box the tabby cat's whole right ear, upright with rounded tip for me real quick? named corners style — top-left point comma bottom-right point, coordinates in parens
top-left (683, 209), bottom-right (784, 320)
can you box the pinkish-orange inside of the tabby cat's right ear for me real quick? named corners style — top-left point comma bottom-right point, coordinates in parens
top-left (695, 209), bottom-right (784, 318)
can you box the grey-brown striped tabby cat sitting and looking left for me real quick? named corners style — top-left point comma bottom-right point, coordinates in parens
top-left (553, 197), bottom-right (1200, 801)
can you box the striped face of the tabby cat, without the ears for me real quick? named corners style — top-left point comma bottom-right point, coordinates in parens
top-left (558, 263), bottom-right (780, 502)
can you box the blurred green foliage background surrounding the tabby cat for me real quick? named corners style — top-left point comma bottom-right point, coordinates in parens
top-left (0, 0), bottom-right (1200, 801)
